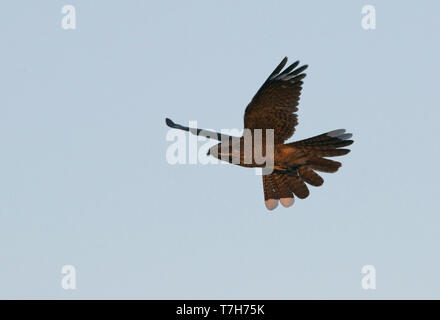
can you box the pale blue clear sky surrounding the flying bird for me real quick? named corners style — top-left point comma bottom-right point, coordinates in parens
top-left (0, 0), bottom-right (440, 299)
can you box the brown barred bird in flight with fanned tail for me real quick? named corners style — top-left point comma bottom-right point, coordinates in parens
top-left (165, 57), bottom-right (354, 210)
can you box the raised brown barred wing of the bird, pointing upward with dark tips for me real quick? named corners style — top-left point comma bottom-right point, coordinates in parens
top-left (244, 57), bottom-right (307, 144)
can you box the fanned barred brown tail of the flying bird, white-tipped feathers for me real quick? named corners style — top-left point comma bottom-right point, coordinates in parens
top-left (263, 129), bottom-right (353, 210)
